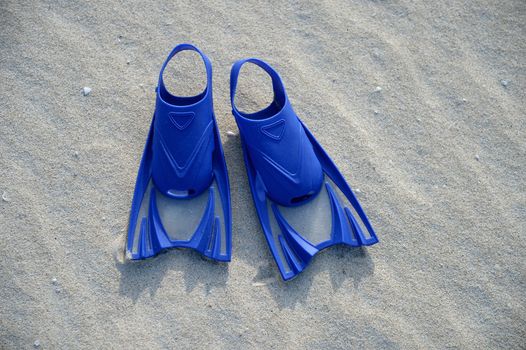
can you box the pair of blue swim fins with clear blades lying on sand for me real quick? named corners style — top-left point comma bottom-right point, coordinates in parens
top-left (125, 44), bottom-right (378, 280)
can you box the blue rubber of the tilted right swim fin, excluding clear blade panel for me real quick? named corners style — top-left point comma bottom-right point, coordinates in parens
top-left (230, 58), bottom-right (378, 280)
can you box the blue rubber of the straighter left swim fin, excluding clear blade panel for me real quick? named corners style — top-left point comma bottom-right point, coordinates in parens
top-left (126, 44), bottom-right (232, 261)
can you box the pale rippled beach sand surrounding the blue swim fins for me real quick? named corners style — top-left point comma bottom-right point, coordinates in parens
top-left (0, 0), bottom-right (526, 349)
